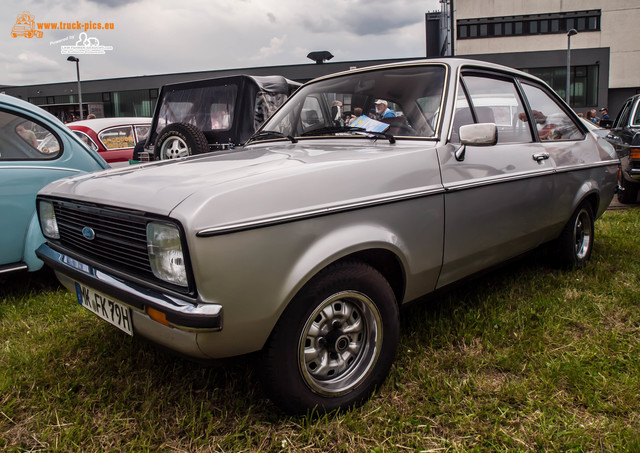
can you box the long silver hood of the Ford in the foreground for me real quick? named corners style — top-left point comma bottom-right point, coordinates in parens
top-left (40, 139), bottom-right (437, 227)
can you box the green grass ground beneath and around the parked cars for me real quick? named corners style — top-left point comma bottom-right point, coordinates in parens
top-left (0, 209), bottom-right (640, 452)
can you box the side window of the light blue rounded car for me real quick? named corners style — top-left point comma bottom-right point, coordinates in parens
top-left (0, 112), bottom-right (61, 160)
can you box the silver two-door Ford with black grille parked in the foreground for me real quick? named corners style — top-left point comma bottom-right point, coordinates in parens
top-left (38, 59), bottom-right (619, 413)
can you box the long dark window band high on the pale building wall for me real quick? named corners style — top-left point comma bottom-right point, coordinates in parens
top-left (457, 9), bottom-right (601, 39)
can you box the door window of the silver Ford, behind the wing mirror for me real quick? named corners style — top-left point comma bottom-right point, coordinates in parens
top-left (463, 75), bottom-right (532, 143)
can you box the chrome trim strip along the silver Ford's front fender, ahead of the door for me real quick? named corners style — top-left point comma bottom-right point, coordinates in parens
top-left (196, 187), bottom-right (445, 237)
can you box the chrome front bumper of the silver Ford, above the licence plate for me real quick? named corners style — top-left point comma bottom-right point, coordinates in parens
top-left (36, 243), bottom-right (222, 332)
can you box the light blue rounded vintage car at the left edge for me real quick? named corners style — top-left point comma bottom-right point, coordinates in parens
top-left (0, 94), bottom-right (108, 274)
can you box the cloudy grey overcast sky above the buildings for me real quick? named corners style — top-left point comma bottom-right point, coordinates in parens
top-left (0, 0), bottom-right (440, 85)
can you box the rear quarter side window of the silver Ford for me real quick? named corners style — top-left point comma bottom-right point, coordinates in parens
top-left (522, 83), bottom-right (584, 141)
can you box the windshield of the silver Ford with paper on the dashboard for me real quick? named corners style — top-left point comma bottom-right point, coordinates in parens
top-left (254, 64), bottom-right (446, 140)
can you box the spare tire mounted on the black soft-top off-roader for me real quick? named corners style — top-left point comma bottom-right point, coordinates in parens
top-left (154, 123), bottom-right (209, 160)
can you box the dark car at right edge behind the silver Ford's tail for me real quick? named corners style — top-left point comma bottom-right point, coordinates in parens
top-left (607, 94), bottom-right (640, 203)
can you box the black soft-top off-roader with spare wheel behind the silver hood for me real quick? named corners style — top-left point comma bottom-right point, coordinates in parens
top-left (135, 75), bottom-right (300, 161)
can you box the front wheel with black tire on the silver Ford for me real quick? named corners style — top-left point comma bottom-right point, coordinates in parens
top-left (258, 262), bottom-right (400, 414)
